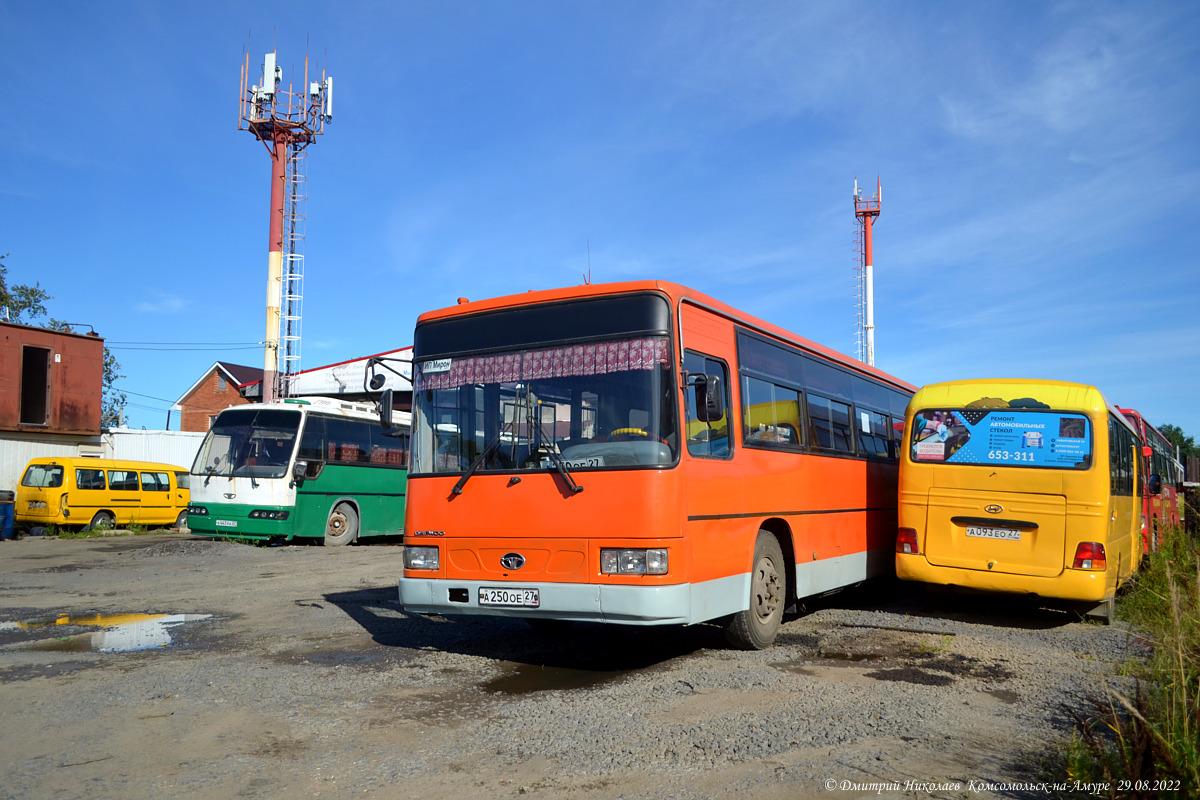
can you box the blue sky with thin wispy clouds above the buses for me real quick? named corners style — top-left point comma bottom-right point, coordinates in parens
top-left (0, 0), bottom-right (1200, 438)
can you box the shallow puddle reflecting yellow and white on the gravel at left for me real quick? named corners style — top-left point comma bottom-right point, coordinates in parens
top-left (2, 614), bottom-right (211, 652)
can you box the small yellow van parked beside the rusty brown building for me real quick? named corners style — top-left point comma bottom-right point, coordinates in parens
top-left (13, 457), bottom-right (191, 530)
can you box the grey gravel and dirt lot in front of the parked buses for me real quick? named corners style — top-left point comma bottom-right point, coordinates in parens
top-left (0, 534), bottom-right (1141, 800)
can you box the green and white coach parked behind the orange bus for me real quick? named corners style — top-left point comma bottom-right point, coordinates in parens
top-left (187, 397), bottom-right (410, 545)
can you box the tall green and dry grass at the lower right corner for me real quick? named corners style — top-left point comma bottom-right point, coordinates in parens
top-left (1067, 515), bottom-right (1200, 799)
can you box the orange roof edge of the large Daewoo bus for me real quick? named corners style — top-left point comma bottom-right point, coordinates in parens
top-left (416, 281), bottom-right (917, 392)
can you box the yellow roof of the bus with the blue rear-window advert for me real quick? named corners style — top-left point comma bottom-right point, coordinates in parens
top-left (908, 378), bottom-right (1141, 431)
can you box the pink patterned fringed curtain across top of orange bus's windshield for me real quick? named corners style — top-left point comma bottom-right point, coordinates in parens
top-left (414, 337), bottom-right (671, 391)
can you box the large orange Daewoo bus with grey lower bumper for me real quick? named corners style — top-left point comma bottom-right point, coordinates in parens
top-left (382, 281), bottom-right (914, 649)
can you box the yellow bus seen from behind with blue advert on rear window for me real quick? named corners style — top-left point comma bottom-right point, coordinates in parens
top-left (896, 380), bottom-right (1141, 621)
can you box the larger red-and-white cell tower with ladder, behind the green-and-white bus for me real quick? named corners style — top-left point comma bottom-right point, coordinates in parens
top-left (238, 53), bottom-right (334, 403)
